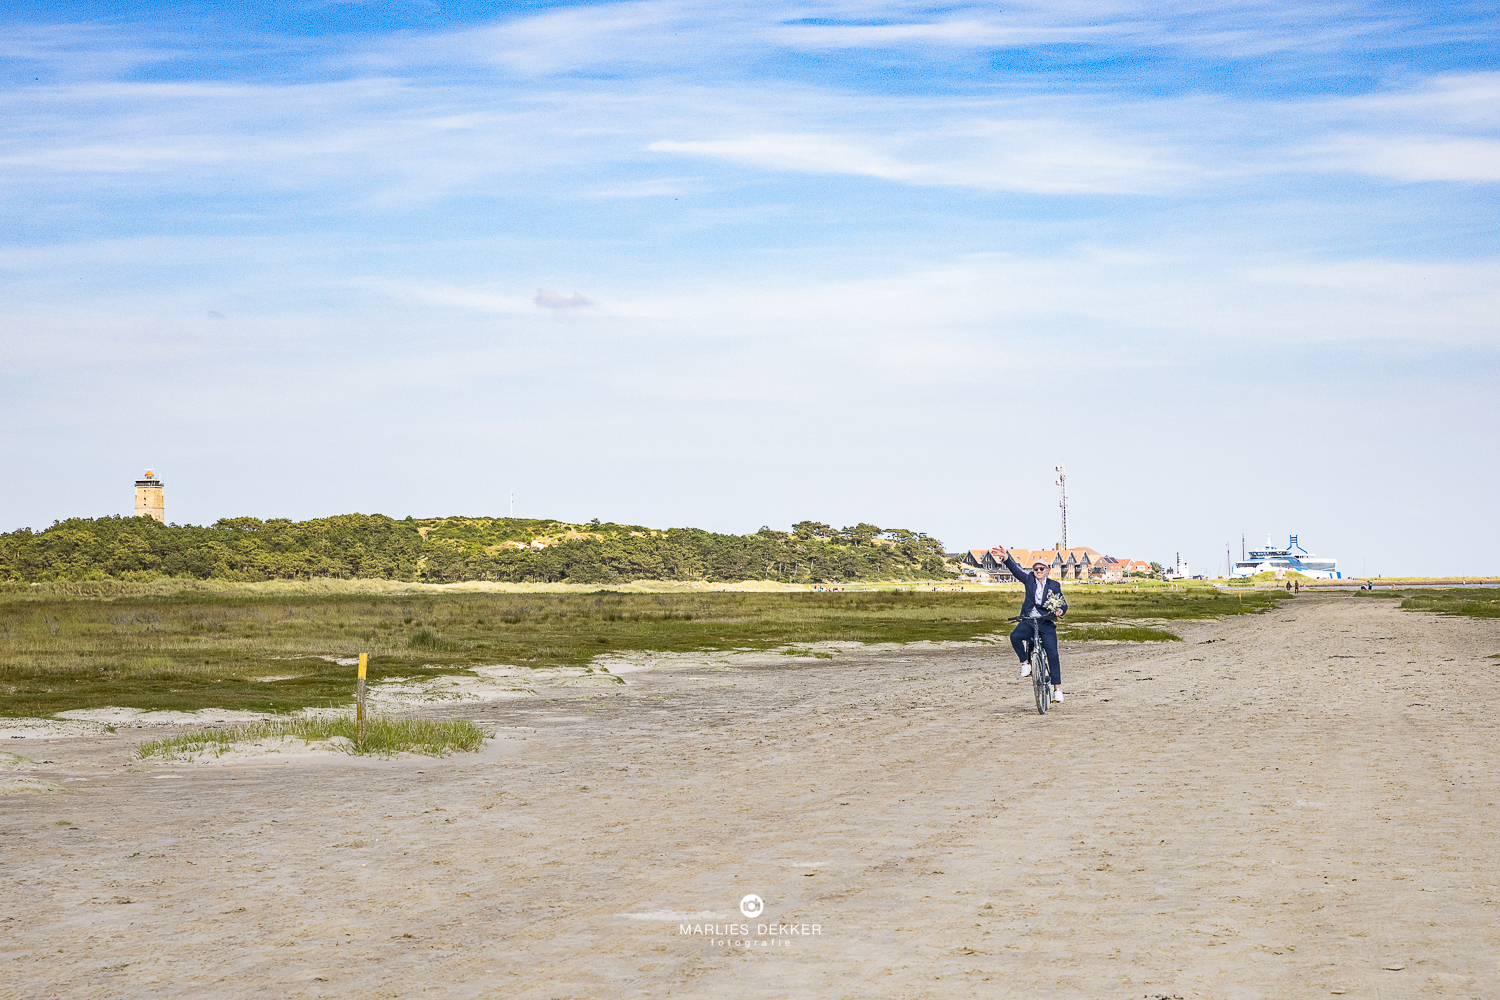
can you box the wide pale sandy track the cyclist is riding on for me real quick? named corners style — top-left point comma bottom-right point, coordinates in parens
top-left (0, 595), bottom-right (1500, 1000)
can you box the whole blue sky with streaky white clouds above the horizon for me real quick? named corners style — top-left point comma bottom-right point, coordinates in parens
top-left (0, 0), bottom-right (1500, 576)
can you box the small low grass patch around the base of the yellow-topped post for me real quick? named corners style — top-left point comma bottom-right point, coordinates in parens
top-left (135, 718), bottom-right (491, 760)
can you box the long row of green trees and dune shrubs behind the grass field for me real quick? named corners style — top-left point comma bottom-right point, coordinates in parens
top-left (0, 514), bottom-right (950, 583)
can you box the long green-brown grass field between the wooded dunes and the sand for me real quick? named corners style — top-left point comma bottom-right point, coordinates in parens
top-left (0, 585), bottom-right (1286, 717)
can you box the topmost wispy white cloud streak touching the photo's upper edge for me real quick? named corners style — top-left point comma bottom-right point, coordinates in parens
top-left (360, 0), bottom-right (1484, 76)
